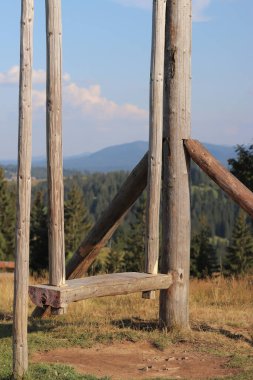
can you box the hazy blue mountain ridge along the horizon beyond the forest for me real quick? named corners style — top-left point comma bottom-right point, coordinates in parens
top-left (0, 141), bottom-right (236, 172)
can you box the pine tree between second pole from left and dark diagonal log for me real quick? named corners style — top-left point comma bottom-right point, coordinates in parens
top-left (64, 185), bottom-right (91, 257)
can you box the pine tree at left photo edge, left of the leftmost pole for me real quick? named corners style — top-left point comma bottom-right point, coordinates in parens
top-left (0, 168), bottom-right (15, 260)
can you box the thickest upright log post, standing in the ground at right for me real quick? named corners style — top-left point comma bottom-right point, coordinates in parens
top-left (160, 0), bottom-right (192, 328)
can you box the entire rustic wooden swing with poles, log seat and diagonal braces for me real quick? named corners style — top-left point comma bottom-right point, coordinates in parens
top-left (13, 0), bottom-right (253, 379)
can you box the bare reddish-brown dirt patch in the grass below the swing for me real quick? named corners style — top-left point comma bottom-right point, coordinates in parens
top-left (32, 342), bottom-right (237, 380)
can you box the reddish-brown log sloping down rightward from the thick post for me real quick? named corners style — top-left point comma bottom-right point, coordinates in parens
top-left (184, 140), bottom-right (253, 218)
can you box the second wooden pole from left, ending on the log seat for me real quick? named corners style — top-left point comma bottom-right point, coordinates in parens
top-left (46, 0), bottom-right (65, 286)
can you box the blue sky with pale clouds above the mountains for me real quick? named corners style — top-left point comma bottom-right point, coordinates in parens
top-left (0, 0), bottom-right (253, 159)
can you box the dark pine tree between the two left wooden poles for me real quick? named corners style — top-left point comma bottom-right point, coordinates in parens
top-left (30, 191), bottom-right (49, 274)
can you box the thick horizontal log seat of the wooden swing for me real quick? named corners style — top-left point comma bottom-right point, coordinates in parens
top-left (29, 272), bottom-right (172, 308)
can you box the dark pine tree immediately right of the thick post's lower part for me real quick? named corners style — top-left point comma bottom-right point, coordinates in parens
top-left (190, 225), bottom-right (218, 278)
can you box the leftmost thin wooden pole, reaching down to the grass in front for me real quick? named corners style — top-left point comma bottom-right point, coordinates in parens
top-left (13, 0), bottom-right (33, 379)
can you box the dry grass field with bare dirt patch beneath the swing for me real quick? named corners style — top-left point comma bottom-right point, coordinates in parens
top-left (0, 274), bottom-right (253, 380)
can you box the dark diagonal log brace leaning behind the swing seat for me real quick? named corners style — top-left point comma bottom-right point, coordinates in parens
top-left (32, 153), bottom-right (148, 318)
